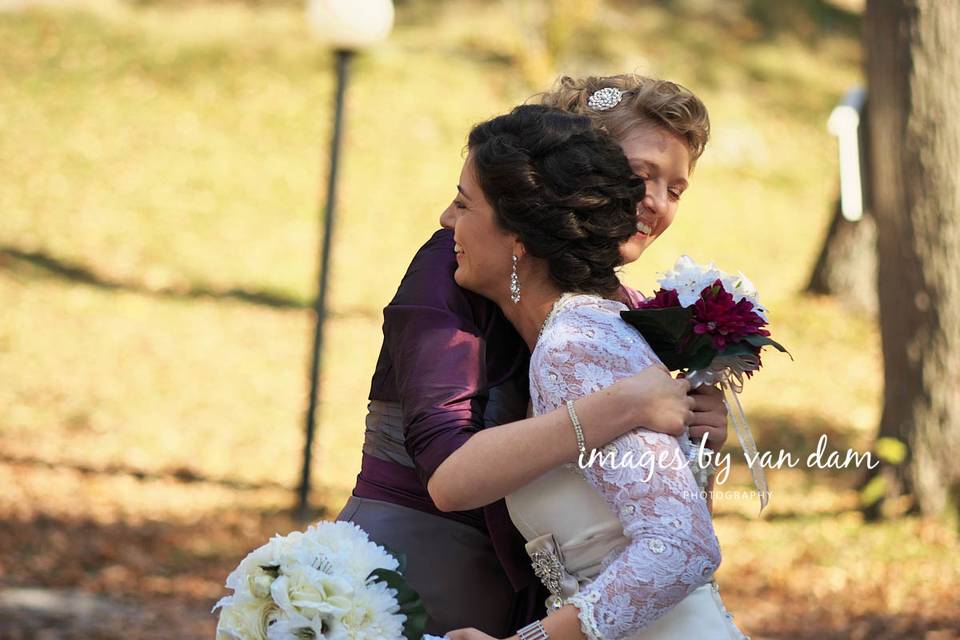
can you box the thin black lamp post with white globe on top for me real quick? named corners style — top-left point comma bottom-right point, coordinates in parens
top-left (297, 0), bottom-right (393, 520)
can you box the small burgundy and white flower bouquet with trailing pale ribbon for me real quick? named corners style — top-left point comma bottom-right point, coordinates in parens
top-left (620, 256), bottom-right (786, 511)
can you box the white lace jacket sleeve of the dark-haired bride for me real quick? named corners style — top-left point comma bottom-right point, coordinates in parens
top-left (530, 302), bottom-right (720, 640)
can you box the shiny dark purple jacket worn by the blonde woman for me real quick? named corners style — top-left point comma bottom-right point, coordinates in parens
top-left (353, 230), bottom-right (642, 591)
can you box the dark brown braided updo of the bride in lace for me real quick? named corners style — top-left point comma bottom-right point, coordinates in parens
top-left (467, 105), bottom-right (644, 296)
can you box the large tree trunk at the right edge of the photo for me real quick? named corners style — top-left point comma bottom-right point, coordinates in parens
top-left (864, 0), bottom-right (960, 517)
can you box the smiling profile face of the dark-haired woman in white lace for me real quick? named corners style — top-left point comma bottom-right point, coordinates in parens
top-left (440, 156), bottom-right (521, 303)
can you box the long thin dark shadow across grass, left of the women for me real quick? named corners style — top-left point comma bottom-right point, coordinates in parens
top-left (0, 246), bottom-right (380, 318)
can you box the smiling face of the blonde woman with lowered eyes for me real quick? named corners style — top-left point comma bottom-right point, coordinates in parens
top-left (618, 126), bottom-right (691, 264)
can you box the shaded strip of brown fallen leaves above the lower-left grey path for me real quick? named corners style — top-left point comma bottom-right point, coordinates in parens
top-left (0, 508), bottom-right (303, 592)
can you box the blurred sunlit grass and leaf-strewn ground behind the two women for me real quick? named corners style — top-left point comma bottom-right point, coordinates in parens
top-left (0, 0), bottom-right (960, 639)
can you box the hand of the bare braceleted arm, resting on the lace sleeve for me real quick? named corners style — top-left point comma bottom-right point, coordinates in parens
top-left (610, 363), bottom-right (692, 436)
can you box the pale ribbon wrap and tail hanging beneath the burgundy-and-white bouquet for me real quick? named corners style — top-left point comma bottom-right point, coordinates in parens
top-left (685, 354), bottom-right (770, 513)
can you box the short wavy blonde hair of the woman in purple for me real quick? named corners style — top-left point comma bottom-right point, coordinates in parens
top-left (533, 73), bottom-right (710, 168)
